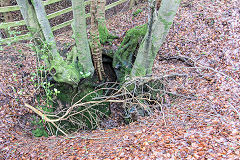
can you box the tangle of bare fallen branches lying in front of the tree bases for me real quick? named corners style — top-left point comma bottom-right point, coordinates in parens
top-left (25, 74), bottom-right (191, 135)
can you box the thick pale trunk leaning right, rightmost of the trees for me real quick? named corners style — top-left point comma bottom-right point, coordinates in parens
top-left (131, 0), bottom-right (181, 77)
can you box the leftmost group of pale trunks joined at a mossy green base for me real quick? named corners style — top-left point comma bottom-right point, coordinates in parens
top-left (17, 0), bottom-right (93, 86)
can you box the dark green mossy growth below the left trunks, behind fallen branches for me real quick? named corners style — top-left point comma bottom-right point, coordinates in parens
top-left (32, 78), bottom-right (110, 137)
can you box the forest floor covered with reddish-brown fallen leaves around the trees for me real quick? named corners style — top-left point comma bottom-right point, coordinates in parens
top-left (0, 0), bottom-right (240, 159)
